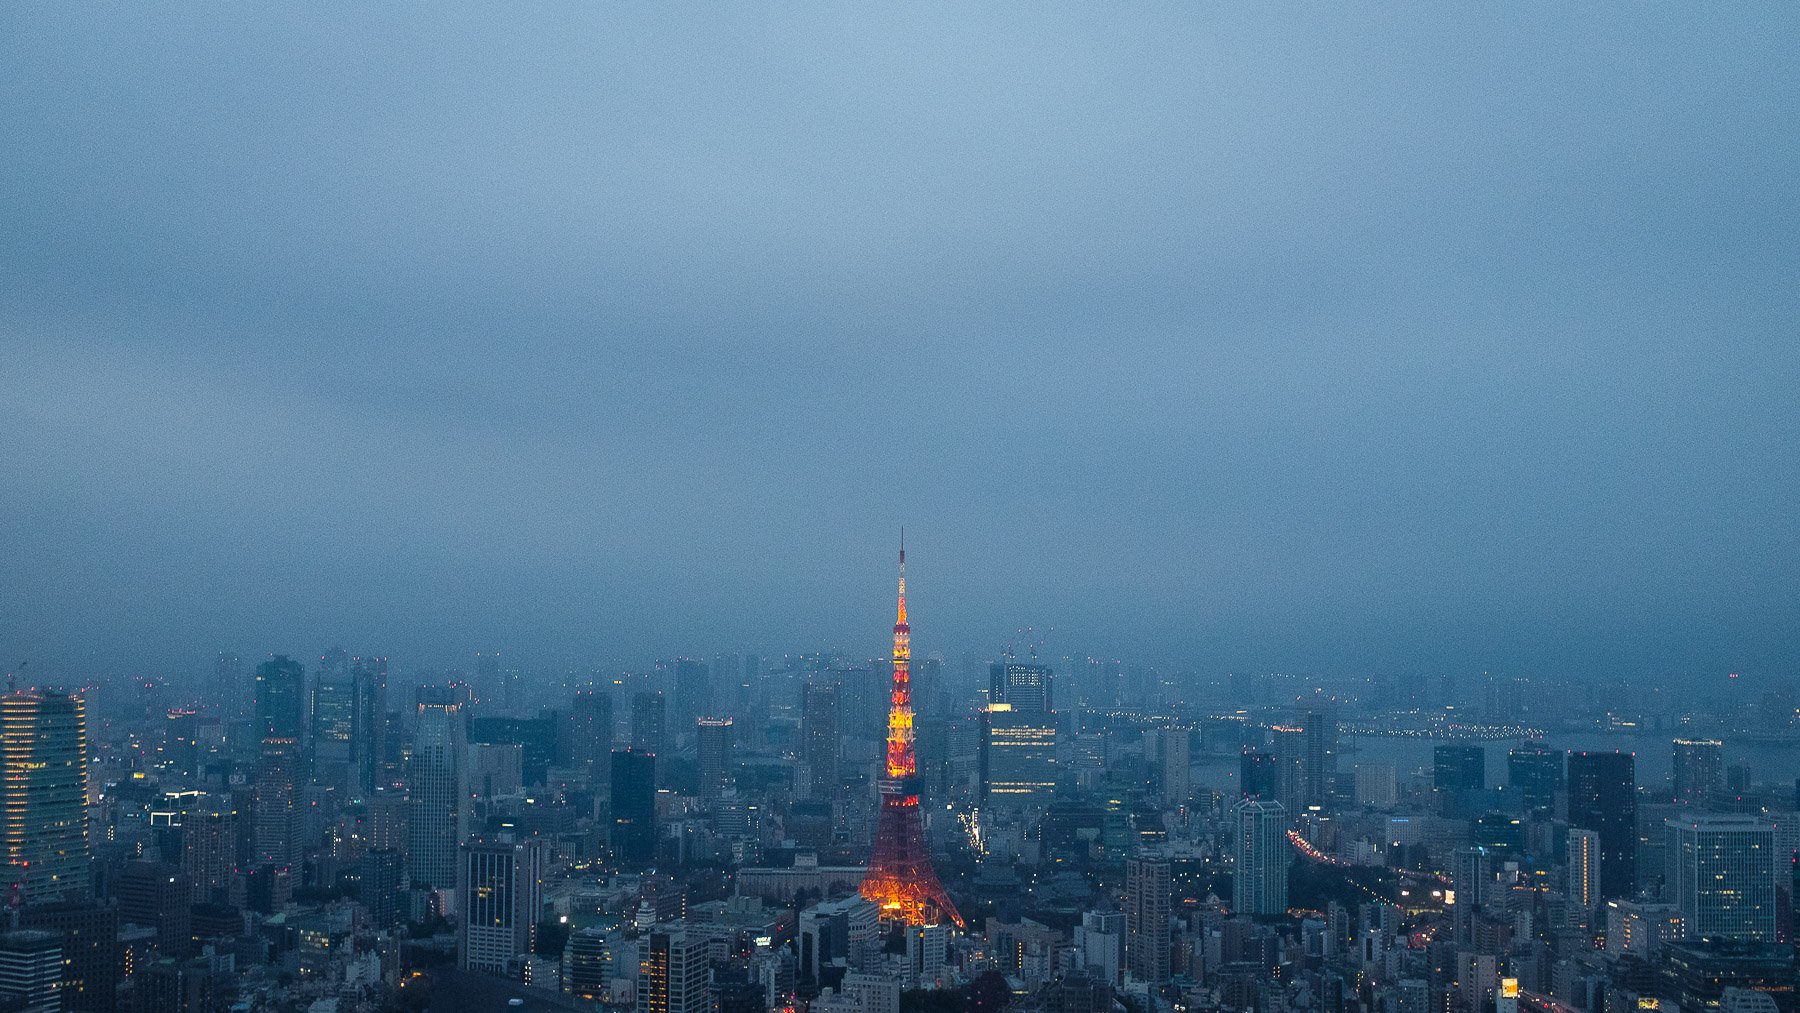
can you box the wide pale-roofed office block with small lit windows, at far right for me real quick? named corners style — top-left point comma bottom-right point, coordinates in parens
top-left (1663, 815), bottom-right (1775, 943)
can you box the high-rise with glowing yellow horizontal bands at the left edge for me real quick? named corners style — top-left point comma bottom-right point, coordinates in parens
top-left (0, 689), bottom-right (94, 903)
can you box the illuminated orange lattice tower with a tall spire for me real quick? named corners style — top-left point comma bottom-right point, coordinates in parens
top-left (862, 538), bottom-right (963, 927)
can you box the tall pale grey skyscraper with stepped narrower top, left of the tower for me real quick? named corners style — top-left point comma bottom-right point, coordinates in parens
top-left (407, 686), bottom-right (470, 891)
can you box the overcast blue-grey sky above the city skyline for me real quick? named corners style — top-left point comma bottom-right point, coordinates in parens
top-left (0, 4), bottom-right (1800, 678)
